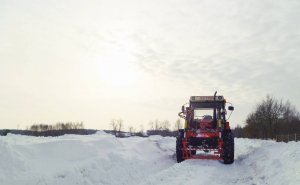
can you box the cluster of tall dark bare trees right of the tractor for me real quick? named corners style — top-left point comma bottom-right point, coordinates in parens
top-left (234, 95), bottom-right (300, 139)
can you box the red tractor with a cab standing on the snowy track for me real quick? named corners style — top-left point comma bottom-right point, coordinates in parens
top-left (176, 92), bottom-right (234, 164)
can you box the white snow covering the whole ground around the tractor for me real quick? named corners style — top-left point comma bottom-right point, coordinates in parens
top-left (0, 132), bottom-right (300, 185)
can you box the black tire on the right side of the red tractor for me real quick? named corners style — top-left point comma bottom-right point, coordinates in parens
top-left (222, 132), bottom-right (234, 164)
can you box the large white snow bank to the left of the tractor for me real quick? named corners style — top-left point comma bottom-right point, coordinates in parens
top-left (0, 132), bottom-right (174, 185)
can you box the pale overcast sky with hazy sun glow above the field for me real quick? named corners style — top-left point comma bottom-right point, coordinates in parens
top-left (0, 0), bottom-right (300, 129)
